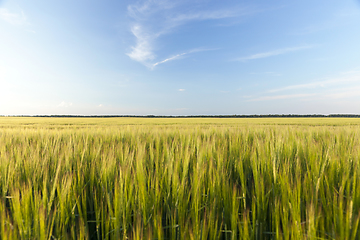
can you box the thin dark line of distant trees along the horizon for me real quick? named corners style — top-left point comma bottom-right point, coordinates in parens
top-left (0, 114), bottom-right (360, 118)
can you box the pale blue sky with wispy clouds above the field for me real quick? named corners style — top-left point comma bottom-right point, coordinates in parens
top-left (0, 0), bottom-right (360, 115)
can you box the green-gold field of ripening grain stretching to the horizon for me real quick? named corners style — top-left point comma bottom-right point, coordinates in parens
top-left (0, 117), bottom-right (360, 240)
